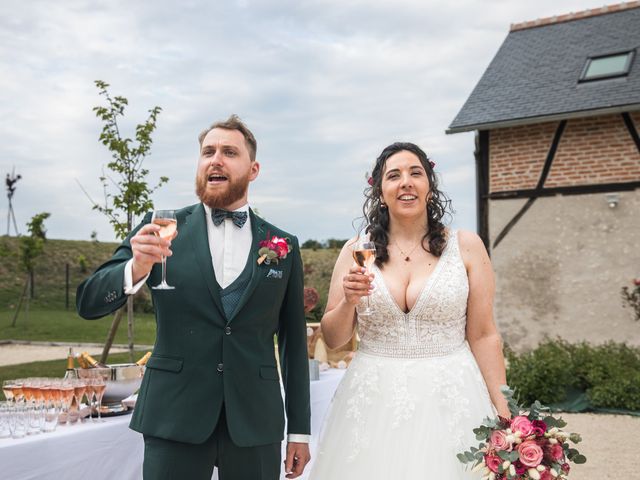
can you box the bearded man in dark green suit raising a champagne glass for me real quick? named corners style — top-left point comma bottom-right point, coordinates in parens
top-left (76, 115), bottom-right (310, 480)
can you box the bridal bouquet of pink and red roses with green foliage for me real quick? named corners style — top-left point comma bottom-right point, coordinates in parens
top-left (458, 386), bottom-right (587, 480)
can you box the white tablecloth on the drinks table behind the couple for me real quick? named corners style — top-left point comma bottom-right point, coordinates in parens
top-left (0, 370), bottom-right (345, 480)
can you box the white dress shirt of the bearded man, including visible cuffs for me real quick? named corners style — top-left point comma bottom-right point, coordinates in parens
top-left (124, 204), bottom-right (311, 443)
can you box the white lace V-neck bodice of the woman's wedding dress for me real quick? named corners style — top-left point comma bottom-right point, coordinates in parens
top-left (358, 230), bottom-right (469, 358)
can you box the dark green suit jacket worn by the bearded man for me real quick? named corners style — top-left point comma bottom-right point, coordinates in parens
top-left (76, 204), bottom-right (310, 447)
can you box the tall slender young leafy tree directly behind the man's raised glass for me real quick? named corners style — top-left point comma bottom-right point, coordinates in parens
top-left (81, 80), bottom-right (169, 363)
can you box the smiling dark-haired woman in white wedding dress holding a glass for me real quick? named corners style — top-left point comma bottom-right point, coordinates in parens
top-left (310, 143), bottom-right (510, 480)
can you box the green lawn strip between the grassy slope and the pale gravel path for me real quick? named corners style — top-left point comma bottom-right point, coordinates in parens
top-left (0, 308), bottom-right (156, 345)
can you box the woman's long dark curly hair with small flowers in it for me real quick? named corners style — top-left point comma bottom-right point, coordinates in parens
top-left (362, 142), bottom-right (451, 267)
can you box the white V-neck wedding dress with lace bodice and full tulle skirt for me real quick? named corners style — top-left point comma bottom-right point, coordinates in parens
top-left (309, 231), bottom-right (495, 480)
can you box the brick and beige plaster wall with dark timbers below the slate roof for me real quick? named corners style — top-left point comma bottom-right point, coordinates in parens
top-left (488, 112), bottom-right (640, 350)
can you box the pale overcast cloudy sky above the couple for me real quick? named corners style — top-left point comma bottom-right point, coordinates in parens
top-left (0, 0), bottom-right (604, 241)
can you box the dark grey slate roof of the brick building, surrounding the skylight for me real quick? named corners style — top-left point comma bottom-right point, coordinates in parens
top-left (449, 8), bottom-right (640, 132)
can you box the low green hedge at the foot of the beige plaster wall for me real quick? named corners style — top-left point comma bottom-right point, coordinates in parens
top-left (505, 340), bottom-right (640, 412)
